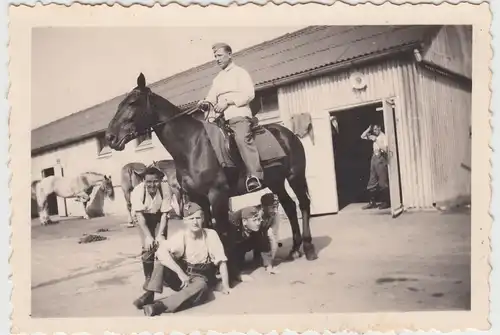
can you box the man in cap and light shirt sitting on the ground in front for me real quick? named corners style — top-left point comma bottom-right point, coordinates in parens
top-left (138, 203), bottom-right (230, 316)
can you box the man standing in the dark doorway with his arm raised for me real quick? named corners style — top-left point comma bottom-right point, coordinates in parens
top-left (361, 124), bottom-right (390, 209)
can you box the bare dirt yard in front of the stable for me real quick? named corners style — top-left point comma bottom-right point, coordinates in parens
top-left (31, 210), bottom-right (470, 317)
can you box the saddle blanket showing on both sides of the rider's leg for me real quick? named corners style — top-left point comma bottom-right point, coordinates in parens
top-left (203, 122), bottom-right (286, 167)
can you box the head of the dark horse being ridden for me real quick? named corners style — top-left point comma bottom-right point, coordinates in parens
top-left (106, 73), bottom-right (156, 151)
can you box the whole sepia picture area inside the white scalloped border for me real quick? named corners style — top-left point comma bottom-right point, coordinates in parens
top-left (7, 2), bottom-right (492, 331)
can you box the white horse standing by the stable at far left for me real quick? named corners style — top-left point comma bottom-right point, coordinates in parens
top-left (31, 172), bottom-right (115, 226)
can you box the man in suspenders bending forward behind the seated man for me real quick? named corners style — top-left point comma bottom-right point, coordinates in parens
top-left (130, 166), bottom-right (172, 308)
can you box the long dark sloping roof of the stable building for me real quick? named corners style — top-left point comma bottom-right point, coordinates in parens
top-left (31, 25), bottom-right (436, 154)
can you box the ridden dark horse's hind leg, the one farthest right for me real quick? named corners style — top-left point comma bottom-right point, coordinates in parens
top-left (288, 175), bottom-right (318, 261)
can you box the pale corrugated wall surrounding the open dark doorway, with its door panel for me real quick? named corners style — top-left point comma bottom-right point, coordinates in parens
top-left (278, 56), bottom-right (433, 214)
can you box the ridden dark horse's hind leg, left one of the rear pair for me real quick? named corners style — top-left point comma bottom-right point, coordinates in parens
top-left (269, 180), bottom-right (302, 259)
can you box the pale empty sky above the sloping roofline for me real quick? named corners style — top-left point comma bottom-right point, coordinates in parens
top-left (31, 26), bottom-right (304, 129)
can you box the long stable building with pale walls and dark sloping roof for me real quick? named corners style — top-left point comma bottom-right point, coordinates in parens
top-left (31, 25), bottom-right (472, 220)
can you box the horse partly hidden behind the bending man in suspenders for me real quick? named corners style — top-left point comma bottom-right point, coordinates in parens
top-left (121, 160), bottom-right (184, 225)
